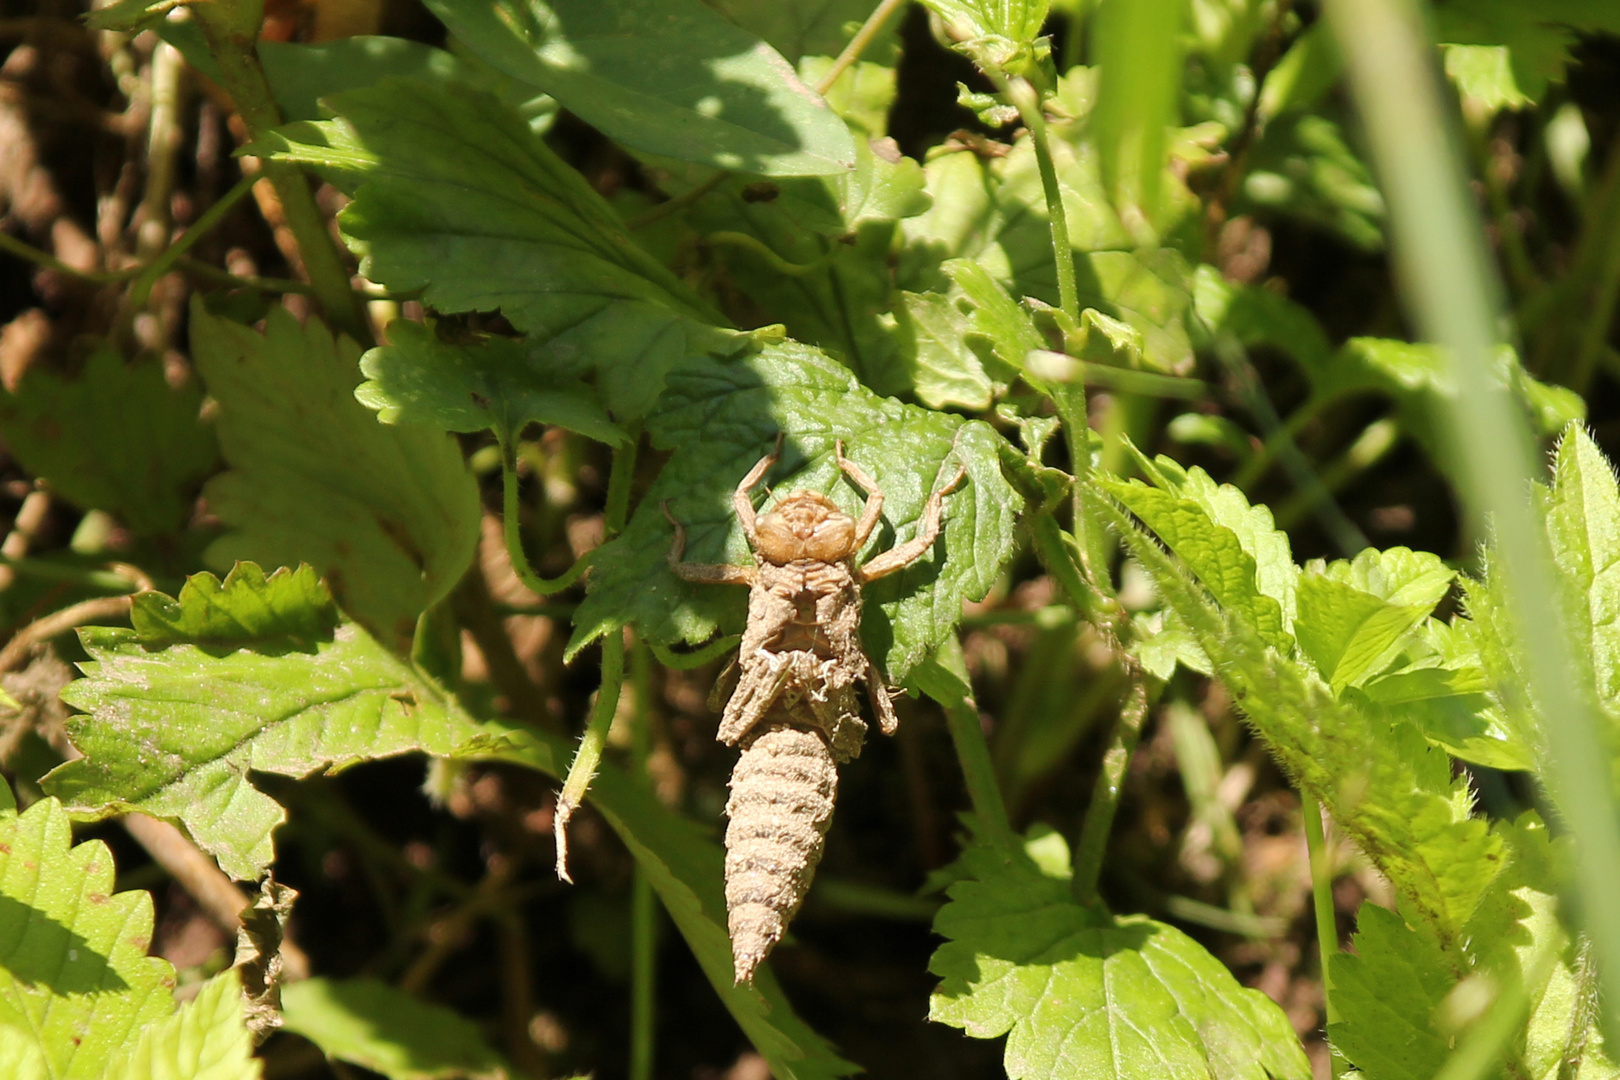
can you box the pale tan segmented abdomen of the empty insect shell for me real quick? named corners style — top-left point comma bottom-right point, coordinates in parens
top-left (726, 719), bottom-right (838, 983)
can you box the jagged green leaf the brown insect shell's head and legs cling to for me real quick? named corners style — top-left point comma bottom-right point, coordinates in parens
top-left (569, 342), bottom-right (1022, 682)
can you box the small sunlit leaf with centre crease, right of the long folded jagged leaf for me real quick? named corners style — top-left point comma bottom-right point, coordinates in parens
top-left (1294, 547), bottom-right (1456, 693)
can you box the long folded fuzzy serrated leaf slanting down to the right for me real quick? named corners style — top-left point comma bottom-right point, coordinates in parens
top-left (1089, 481), bottom-right (1503, 950)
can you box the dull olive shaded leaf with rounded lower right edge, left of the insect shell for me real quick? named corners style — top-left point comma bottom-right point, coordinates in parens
top-left (191, 301), bottom-right (480, 644)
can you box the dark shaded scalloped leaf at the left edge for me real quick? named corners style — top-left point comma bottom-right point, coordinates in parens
top-left (0, 347), bottom-right (219, 536)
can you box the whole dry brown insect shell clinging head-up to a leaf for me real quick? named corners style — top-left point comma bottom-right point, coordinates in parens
top-left (664, 439), bottom-right (966, 983)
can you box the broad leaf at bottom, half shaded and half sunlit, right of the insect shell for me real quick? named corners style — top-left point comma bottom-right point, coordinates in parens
top-left (928, 819), bottom-right (1311, 1080)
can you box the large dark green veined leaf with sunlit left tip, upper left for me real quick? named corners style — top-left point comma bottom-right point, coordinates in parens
top-left (258, 79), bottom-right (721, 418)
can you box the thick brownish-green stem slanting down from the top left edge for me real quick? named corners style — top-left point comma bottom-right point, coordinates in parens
top-left (191, 2), bottom-right (371, 345)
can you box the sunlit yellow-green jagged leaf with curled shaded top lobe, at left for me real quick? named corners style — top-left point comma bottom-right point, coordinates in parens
top-left (44, 567), bottom-right (481, 879)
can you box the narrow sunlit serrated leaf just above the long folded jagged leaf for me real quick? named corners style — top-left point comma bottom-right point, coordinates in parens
top-left (1102, 470), bottom-right (1293, 647)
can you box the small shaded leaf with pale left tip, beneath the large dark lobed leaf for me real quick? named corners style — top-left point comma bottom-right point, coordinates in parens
top-left (355, 319), bottom-right (625, 445)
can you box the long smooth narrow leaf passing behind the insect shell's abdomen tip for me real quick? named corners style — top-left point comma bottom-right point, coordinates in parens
top-left (476, 729), bottom-right (857, 1080)
